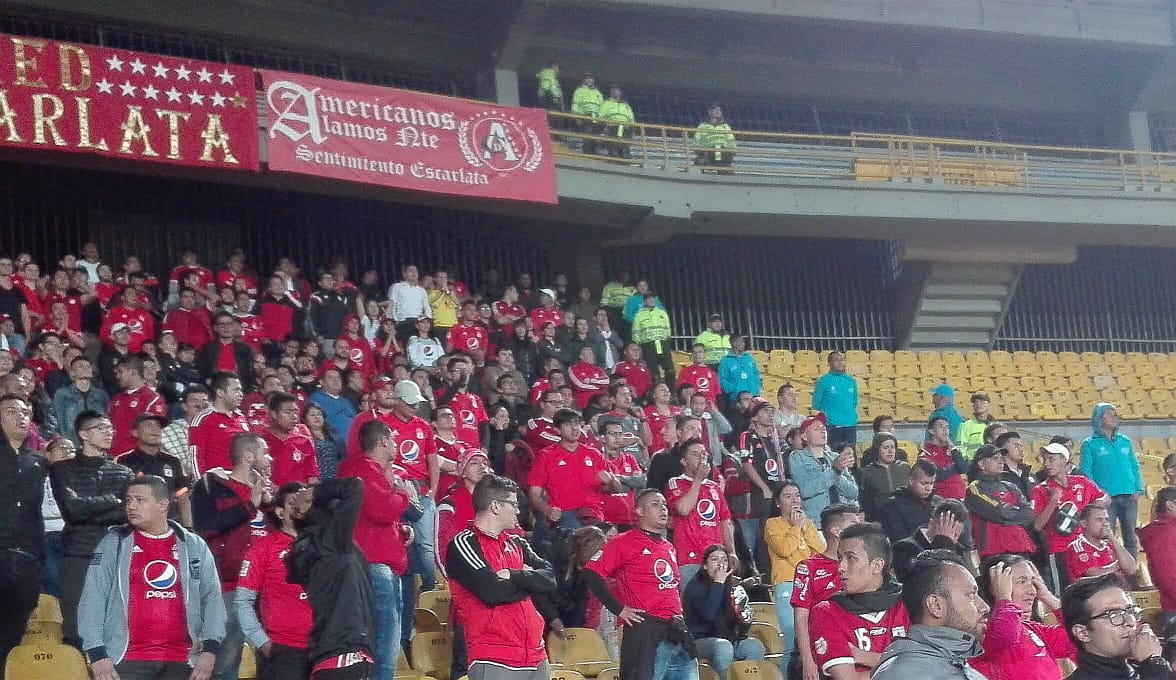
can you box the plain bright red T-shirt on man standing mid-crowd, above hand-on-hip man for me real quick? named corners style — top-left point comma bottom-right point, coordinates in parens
top-left (527, 444), bottom-right (608, 519)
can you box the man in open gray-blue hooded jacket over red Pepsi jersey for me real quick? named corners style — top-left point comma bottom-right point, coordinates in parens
top-left (78, 475), bottom-right (227, 680)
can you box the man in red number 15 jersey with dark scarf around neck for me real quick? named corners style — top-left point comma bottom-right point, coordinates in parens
top-left (809, 522), bottom-right (910, 680)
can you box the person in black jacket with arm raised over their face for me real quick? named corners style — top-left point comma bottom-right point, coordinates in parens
top-left (286, 479), bottom-right (374, 680)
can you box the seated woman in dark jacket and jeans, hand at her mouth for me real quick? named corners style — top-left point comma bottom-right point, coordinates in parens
top-left (682, 545), bottom-right (764, 678)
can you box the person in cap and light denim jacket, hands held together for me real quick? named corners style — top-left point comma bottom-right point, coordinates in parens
top-left (788, 413), bottom-right (857, 516)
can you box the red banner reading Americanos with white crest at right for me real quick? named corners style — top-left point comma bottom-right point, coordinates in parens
top-left (261, 71), bottom-right (556, 204)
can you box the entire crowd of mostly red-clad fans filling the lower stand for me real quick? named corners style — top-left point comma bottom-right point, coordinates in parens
top-left (0, 244), bottom-right (1176, 680)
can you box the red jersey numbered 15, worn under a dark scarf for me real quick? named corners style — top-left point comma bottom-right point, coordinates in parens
top-left (809, 600), bottom-right (910, 675)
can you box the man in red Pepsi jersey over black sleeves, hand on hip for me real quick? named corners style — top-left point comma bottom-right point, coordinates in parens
top-left (583, 488), bottom-right (699, 680)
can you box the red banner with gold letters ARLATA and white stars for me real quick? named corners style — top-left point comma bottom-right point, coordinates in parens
top-left (0, 35), bottom-right (259, 171)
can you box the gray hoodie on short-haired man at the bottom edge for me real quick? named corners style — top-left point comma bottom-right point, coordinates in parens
top-left (870, 624), bottom-right (985, 680)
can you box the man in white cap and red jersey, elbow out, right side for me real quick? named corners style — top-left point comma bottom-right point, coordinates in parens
top-left (1030, 444), bottom-right (1110, 593)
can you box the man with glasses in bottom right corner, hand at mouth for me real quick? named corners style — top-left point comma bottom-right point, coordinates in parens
top-left (1062, 574), bottom-right (1172, 680)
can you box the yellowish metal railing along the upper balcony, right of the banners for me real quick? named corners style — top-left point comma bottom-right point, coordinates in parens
top-left (550, 112), bottom-right (1176, 192)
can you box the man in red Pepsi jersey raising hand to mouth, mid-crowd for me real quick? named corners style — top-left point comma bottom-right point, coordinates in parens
top-left (666, 439), bottom-right (739, 588)
